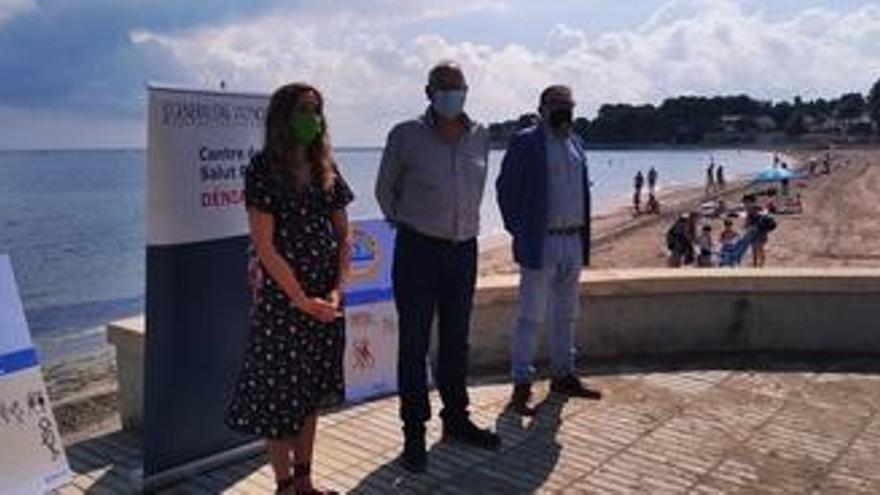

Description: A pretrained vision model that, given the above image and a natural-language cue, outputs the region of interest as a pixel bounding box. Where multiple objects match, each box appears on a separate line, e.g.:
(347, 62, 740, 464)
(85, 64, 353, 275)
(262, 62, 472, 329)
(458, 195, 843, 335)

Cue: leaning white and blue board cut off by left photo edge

(0, 255, 71, 495)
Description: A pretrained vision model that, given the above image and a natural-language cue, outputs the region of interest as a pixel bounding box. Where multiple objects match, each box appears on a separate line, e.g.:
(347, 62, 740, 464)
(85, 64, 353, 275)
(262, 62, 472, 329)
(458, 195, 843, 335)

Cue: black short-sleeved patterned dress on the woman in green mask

(226, 154, 354, 439)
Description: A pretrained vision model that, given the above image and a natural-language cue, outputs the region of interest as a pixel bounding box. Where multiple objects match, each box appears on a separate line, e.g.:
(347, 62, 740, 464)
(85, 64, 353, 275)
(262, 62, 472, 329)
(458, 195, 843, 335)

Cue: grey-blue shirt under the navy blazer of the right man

(544, 128, 587, 229)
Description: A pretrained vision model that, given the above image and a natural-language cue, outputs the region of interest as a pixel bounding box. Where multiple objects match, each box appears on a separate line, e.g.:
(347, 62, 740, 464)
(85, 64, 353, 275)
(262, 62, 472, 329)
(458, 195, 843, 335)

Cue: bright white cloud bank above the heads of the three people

(132, 0, 880, 143)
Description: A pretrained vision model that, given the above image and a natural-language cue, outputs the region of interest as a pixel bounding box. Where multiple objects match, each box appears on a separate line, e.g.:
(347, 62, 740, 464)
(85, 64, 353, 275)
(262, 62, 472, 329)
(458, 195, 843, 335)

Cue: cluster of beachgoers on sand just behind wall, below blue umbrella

(666, 194, 776, 268)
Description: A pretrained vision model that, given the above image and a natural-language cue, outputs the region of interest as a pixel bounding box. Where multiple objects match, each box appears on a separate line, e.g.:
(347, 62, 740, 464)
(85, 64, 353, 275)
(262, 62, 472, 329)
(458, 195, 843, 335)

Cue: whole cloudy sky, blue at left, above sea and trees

(0, 0, 880, 149)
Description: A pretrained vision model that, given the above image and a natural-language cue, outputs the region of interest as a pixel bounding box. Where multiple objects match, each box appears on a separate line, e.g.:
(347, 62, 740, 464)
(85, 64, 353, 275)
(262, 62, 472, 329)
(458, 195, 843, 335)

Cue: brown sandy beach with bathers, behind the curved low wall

(480, 149, 880, 276)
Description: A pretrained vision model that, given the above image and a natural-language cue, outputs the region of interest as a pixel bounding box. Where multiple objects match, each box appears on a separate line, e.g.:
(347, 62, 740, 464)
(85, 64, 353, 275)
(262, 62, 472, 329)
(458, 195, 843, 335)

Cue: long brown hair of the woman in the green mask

(263, 83, 336, 190)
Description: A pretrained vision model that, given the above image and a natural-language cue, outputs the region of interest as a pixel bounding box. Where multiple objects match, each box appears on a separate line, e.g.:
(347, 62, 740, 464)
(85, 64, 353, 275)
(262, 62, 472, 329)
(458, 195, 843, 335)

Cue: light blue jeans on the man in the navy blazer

(510, 235, 583, 384)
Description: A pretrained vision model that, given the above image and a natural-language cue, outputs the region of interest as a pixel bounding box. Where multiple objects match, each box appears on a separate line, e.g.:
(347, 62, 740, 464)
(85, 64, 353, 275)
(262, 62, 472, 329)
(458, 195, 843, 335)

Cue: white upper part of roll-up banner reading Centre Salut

(147, 87, 268, 246)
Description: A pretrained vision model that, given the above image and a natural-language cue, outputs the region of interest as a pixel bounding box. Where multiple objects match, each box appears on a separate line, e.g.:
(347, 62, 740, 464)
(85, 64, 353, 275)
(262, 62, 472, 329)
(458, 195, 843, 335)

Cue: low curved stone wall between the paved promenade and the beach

(108, 268, 880, 429)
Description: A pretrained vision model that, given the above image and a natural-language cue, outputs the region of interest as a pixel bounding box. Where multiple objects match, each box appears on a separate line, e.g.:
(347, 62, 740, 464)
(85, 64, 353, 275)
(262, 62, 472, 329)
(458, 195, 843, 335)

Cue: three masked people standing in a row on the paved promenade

(226, 62, 601, 494)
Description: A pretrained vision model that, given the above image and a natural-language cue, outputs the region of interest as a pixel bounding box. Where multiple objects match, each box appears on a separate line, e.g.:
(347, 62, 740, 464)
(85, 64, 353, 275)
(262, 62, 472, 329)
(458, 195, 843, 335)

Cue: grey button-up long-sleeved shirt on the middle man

(376, 111, 489, 241)
